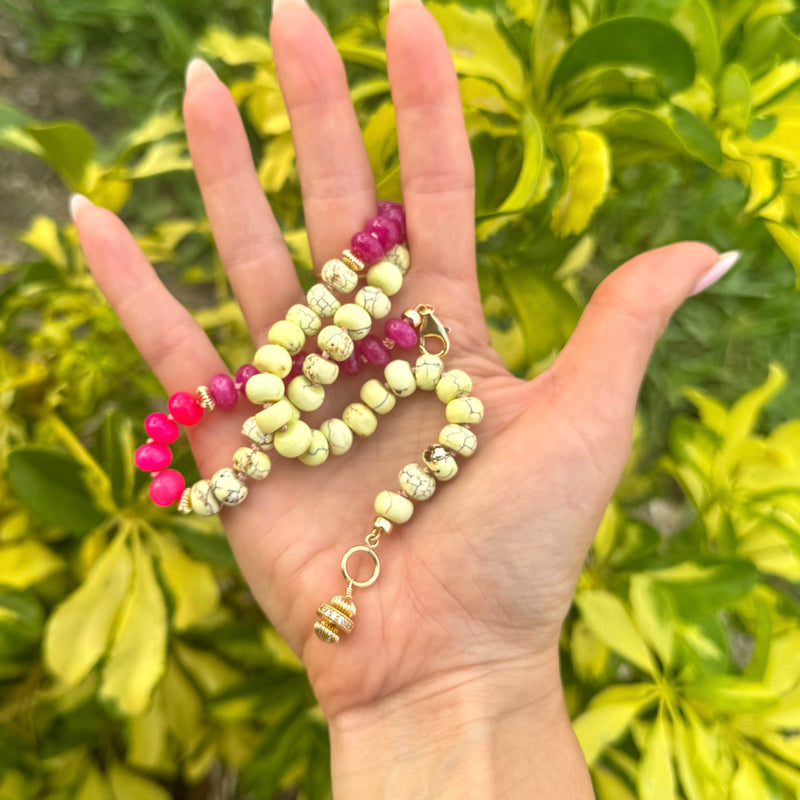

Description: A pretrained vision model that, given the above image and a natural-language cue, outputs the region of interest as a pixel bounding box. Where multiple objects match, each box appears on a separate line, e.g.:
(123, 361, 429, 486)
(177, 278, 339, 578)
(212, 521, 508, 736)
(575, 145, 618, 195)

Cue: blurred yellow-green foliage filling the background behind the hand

(0, 0, 800, 800)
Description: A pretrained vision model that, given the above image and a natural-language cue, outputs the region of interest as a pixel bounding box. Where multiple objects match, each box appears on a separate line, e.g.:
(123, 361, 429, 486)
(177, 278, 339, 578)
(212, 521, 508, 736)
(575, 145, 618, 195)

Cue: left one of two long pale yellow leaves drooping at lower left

(44, 533, 133, 686)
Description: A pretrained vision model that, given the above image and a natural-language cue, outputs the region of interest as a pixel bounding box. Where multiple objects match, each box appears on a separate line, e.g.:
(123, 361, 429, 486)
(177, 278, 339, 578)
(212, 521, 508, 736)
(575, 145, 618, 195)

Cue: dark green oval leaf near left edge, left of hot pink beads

(8, 446, 105, 533)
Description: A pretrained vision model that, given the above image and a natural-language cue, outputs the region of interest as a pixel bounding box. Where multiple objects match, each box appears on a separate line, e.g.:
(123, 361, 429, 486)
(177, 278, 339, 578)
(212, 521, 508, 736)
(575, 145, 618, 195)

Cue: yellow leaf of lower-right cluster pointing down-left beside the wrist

(573, 683, 658, 767)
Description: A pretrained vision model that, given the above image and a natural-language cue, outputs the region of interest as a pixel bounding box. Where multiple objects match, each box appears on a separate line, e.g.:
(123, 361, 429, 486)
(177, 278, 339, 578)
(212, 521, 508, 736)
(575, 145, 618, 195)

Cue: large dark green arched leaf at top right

(549, 17, 695, 95)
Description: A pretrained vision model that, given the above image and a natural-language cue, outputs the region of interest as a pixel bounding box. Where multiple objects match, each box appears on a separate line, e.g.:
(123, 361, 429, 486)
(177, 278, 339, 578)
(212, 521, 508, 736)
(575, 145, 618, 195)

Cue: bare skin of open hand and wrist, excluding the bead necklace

(76, 2, 717, 800)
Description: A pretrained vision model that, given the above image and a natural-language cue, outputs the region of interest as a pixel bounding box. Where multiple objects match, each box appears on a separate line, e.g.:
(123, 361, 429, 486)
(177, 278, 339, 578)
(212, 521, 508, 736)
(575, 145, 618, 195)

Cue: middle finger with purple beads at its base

(270, 0, 377, 267)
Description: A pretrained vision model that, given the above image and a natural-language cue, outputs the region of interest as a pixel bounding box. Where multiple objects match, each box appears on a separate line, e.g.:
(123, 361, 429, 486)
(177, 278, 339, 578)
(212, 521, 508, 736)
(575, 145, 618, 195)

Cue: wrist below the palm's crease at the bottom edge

(329, 652, 594, 800)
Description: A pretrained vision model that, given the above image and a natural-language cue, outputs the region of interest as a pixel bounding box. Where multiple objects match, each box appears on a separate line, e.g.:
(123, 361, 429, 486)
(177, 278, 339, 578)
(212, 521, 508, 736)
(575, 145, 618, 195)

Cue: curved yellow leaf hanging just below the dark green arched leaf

(550, 129, 611, 236)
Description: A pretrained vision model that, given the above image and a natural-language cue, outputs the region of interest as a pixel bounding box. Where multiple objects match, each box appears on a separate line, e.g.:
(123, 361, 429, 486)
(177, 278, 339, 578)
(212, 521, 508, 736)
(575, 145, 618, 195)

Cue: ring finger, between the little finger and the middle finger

(183, 59, 299, 343)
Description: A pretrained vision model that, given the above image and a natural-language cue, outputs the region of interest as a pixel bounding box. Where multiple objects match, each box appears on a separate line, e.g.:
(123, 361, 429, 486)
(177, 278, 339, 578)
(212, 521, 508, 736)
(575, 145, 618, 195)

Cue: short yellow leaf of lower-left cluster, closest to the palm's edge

(153, 536, 219, 631)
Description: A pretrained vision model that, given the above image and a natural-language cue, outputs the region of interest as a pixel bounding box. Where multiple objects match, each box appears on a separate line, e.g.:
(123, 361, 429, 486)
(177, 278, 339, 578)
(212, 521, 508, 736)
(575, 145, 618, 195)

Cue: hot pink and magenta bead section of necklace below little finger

(134, 364, 258, 506)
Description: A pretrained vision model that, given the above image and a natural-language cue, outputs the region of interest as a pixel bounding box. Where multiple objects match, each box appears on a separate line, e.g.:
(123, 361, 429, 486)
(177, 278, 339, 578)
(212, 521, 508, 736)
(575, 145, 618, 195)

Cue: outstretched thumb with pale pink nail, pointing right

(551, 242, 740, 450)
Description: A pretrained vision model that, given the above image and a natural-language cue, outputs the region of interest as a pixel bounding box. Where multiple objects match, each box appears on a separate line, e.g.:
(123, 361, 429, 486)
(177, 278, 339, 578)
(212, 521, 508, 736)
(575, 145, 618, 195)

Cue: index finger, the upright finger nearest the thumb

(386, 0, 488, 342)
